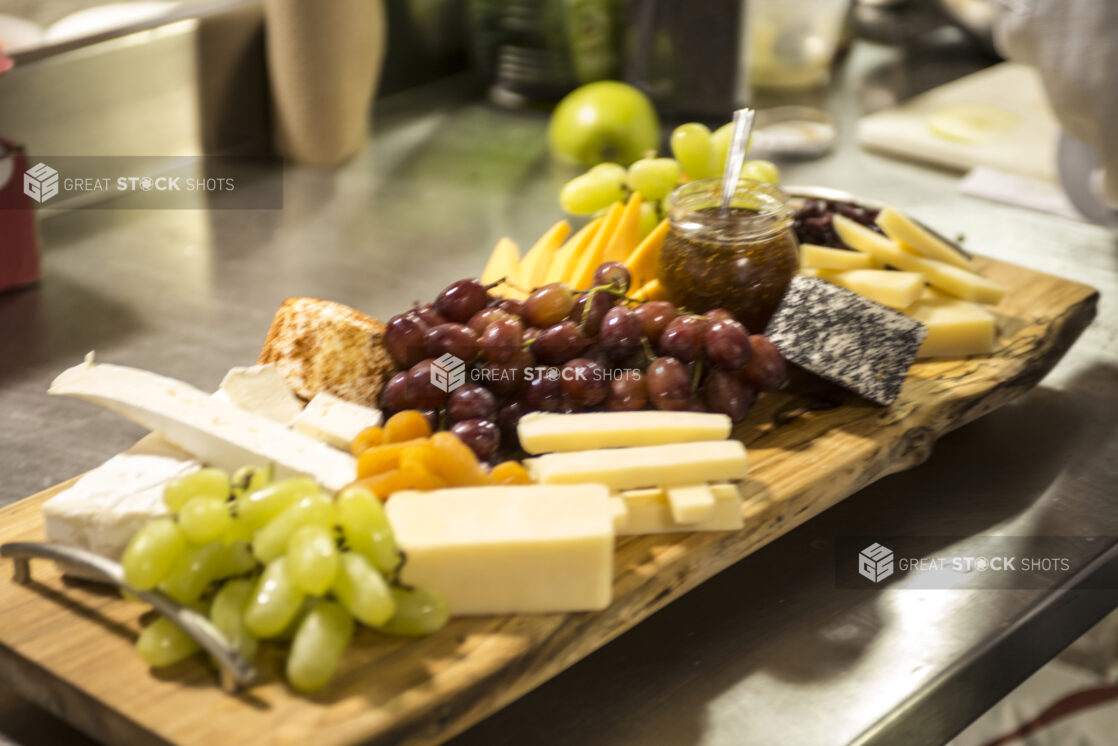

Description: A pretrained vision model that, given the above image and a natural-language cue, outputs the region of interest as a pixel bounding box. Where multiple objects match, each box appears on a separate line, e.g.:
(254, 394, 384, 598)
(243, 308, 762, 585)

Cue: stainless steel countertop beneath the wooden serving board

(0, 36, 1118, 746)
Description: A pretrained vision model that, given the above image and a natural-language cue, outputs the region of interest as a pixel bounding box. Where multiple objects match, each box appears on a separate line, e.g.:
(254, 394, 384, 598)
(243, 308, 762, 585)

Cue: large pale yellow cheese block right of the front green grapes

(386, 484, 614, 615)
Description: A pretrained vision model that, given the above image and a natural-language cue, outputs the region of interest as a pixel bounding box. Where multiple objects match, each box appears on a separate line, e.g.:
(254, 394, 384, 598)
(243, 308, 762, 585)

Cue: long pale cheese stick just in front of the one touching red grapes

(524, 441, 748, 491)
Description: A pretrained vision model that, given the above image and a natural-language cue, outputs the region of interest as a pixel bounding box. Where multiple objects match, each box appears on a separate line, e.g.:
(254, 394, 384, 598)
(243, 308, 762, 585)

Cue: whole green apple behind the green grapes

(548, 81, 660, 166)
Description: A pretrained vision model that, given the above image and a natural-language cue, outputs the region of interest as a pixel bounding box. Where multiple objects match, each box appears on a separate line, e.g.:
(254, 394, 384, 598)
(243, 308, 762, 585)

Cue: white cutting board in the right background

(858, 63, 1060, 182)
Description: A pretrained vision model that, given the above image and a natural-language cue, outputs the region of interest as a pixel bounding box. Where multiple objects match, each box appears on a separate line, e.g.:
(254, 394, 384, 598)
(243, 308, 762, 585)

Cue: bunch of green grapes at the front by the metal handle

(121, 469, 447, 692)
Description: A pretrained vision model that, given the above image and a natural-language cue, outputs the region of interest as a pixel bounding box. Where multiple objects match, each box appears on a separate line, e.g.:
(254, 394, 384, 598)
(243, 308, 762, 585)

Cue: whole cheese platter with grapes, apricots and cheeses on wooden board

(0, 147, 1097, 744)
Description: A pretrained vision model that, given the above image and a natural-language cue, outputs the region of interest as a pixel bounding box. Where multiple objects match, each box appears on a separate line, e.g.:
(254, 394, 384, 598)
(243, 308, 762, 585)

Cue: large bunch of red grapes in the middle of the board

(381, 262, 787, 460)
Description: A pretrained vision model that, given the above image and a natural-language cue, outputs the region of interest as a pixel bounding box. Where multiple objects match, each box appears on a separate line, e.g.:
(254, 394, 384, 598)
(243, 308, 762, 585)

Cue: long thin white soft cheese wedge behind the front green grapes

(48, 356, 357, 491)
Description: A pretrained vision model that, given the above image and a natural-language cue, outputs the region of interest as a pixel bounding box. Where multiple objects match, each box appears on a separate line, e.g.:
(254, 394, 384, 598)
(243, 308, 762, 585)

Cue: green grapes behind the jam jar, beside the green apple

(559, 122, 780, 224)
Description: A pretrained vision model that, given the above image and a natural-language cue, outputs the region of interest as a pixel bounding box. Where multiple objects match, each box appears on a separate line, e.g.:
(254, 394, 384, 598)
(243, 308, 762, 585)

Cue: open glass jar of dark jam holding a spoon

(660, 178, 799, 333)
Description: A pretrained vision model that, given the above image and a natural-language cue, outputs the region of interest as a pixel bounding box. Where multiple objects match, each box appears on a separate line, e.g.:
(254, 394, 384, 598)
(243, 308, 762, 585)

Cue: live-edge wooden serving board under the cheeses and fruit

(0, 257, 1098, 746)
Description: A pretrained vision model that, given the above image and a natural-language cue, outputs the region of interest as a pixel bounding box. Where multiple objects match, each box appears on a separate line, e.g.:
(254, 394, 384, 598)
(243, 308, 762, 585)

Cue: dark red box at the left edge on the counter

(0, 139, 39, 292)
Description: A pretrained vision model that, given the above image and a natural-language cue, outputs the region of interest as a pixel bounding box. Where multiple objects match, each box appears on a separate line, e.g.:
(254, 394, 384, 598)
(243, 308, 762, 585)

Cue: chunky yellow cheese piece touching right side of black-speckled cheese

(906, 290, 997, 358)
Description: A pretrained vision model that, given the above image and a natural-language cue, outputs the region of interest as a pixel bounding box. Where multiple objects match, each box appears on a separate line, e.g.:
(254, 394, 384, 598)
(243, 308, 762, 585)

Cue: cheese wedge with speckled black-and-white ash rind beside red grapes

(765, 276, 928, 406)
